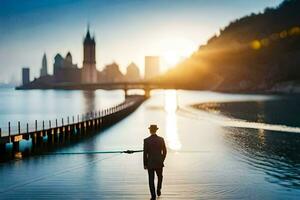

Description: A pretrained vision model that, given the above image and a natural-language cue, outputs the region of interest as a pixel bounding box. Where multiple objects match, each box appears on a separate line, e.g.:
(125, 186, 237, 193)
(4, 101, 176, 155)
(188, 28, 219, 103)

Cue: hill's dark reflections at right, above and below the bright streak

(191, 97, 300, 189)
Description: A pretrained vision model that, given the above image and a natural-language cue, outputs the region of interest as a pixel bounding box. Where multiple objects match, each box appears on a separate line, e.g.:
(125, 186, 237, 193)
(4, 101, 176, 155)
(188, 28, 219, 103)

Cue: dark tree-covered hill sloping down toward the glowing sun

(158, 0, 300, 92)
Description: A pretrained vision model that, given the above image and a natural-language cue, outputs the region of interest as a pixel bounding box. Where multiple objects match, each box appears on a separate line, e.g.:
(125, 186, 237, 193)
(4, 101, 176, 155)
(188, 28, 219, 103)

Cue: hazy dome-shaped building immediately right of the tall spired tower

(100, 62, 124, 83)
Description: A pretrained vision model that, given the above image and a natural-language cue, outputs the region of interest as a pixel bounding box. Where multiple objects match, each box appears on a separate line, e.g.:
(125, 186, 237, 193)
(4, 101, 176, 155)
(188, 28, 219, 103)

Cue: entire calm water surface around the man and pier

(0, 90, 300, 199)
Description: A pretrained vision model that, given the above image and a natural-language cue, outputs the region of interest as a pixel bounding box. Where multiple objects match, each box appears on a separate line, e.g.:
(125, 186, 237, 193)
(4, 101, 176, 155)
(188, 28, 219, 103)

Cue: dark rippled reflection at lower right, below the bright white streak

(225, 128, 300, 189)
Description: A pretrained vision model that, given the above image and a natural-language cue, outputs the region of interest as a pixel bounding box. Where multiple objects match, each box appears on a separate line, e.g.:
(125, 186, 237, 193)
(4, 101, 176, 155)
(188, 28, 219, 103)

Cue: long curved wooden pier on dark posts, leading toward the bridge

(0, 95, 147, 159)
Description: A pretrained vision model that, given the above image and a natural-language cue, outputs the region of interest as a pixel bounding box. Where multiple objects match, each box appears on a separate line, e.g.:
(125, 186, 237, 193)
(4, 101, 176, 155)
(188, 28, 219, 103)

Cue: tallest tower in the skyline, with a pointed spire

(82, 27, 97, 83)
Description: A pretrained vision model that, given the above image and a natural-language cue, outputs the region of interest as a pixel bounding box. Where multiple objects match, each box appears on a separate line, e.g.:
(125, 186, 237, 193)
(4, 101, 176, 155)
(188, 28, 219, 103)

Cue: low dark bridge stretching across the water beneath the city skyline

(16, 81, 177, 98)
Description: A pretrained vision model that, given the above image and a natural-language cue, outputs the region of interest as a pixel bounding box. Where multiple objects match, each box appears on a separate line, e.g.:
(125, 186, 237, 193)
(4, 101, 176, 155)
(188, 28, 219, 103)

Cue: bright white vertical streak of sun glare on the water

(164, 90, 182, 151)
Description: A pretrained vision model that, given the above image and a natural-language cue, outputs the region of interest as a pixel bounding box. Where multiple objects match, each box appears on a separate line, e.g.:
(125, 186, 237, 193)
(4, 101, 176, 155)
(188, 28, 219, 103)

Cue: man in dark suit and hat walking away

(144, 124, 167, 199)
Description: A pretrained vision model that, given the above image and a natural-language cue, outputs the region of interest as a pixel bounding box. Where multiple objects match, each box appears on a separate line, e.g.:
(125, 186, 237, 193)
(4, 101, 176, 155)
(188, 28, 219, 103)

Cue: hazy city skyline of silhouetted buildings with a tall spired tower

(18, 27, 143, 89)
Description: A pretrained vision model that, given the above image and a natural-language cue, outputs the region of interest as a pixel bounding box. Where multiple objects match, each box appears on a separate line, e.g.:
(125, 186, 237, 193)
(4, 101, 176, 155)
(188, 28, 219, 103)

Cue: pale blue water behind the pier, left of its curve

(0, 89, 124, 134)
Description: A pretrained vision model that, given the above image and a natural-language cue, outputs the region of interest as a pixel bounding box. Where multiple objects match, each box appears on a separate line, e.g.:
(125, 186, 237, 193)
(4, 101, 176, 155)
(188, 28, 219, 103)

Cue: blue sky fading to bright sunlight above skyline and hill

(0, 0, 282, 82)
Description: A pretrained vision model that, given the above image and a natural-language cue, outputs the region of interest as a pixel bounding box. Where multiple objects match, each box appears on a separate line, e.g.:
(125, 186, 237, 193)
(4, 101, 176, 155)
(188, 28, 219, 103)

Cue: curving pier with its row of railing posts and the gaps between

(0, 95, 145, 153)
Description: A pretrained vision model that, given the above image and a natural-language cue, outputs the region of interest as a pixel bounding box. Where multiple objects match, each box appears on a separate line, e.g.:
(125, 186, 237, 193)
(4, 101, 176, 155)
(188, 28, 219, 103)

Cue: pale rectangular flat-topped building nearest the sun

(145, 56, 160, 80)
